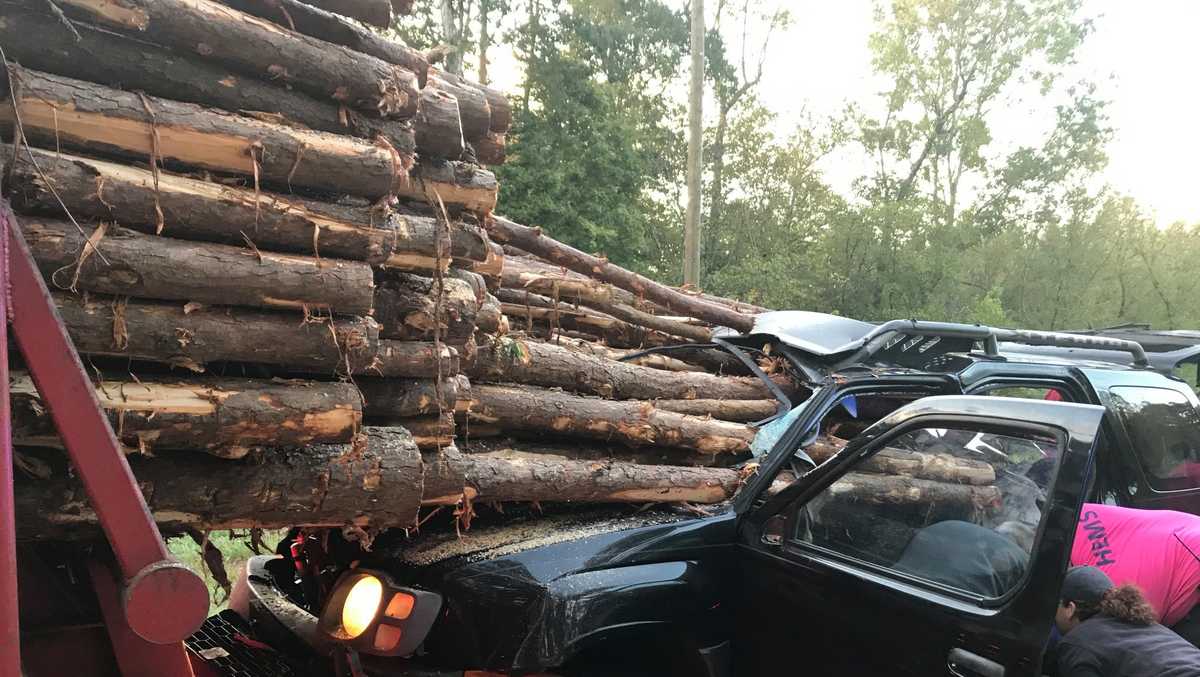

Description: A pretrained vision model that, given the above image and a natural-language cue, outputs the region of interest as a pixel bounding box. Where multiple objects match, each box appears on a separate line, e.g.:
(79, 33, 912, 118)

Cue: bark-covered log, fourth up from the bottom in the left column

(19, 217, 374, 314)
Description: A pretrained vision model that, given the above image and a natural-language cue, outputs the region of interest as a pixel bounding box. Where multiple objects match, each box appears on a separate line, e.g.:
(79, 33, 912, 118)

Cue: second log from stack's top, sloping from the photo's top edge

(221, 0, 430, 81)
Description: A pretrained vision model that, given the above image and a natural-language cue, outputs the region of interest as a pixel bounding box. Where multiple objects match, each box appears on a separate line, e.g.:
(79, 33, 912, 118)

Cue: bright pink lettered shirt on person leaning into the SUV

(1070, 503, 1200, 625)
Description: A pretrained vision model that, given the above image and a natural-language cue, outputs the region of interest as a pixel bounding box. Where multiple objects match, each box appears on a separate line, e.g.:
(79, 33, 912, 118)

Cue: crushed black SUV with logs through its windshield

(235, 312, 1200, 677)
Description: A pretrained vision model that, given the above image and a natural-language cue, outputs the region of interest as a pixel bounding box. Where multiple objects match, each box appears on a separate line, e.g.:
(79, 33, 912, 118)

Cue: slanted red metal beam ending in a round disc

(0, 200, 209, 657)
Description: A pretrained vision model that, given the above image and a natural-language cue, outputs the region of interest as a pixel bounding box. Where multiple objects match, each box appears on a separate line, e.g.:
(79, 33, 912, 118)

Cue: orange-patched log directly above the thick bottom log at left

(8, 372, 362, 459)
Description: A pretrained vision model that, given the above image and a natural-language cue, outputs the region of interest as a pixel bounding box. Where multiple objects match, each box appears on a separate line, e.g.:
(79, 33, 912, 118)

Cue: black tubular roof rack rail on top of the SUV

(844, 319, 1150, 367)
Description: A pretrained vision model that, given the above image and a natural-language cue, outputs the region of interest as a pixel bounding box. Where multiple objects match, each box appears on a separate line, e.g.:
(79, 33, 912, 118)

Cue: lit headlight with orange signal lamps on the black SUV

(318, 569, 442, 655)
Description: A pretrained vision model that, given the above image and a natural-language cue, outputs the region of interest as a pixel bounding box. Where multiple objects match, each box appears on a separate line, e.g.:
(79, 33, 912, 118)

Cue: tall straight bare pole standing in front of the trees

(683, 0, 704, 288)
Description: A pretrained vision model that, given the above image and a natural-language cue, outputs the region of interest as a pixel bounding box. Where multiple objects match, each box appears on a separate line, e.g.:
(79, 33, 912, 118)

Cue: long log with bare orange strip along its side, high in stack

(0, 66, 407, 199)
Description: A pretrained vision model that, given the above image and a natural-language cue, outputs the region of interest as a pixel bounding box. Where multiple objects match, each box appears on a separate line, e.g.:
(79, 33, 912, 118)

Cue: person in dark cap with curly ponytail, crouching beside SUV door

(1055, 567, 1200, 677)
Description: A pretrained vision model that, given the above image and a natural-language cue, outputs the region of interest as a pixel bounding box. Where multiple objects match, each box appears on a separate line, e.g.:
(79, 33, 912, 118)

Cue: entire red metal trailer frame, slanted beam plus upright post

(0, 199, 209, 677)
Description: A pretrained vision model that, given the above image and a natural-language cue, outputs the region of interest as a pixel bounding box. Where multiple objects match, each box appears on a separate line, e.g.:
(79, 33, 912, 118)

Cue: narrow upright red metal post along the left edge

(0, 187, 20, 677)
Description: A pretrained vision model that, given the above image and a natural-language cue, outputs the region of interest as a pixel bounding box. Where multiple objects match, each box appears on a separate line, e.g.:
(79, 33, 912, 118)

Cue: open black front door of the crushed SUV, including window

(732, 396, 1104, 677)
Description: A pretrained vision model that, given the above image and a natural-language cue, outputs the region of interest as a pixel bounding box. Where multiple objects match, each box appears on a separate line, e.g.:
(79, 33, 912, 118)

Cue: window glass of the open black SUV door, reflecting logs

(794, 427, 1058, 598)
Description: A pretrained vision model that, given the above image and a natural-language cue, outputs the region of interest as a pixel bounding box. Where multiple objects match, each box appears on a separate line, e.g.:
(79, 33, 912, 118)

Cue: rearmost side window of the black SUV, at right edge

(1109, 387, 1200, 491)
